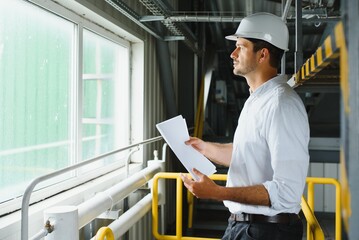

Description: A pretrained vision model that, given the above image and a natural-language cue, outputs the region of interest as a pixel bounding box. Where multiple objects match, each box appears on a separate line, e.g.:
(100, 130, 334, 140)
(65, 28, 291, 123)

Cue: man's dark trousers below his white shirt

(222, 218, 303, 240)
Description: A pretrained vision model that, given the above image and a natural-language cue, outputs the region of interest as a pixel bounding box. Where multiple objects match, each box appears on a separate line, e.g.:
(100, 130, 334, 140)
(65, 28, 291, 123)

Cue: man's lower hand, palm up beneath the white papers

(181, 168, 222, 200)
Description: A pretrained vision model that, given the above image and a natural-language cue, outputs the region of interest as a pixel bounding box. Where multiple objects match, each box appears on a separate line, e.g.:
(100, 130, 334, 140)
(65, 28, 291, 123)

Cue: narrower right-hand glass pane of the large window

(83, 30, 129, 163)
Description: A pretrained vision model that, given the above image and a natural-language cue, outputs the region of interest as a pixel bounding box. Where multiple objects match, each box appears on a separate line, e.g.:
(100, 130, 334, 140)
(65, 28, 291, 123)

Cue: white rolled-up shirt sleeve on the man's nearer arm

(263, 99, 309, 210)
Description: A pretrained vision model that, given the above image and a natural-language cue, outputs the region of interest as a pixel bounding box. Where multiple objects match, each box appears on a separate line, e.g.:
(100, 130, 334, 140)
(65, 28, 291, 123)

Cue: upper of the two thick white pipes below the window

(78, 164, 161, 228)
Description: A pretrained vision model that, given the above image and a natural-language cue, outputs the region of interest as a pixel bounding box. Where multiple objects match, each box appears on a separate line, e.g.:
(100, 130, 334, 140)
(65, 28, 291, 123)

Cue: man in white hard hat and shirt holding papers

(182, 13, 309, 240)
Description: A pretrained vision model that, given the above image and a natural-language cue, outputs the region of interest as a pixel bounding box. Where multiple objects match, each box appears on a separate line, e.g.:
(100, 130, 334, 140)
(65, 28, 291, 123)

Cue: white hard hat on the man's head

(226, 13, 289, 51)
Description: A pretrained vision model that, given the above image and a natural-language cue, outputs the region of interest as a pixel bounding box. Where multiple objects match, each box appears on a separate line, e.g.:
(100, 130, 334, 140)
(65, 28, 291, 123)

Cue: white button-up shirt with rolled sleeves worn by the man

(224, 76, 310, 216)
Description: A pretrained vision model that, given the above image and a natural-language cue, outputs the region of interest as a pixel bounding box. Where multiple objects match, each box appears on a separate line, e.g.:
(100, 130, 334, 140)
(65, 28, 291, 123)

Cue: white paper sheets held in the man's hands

(156, 115, 216, 180)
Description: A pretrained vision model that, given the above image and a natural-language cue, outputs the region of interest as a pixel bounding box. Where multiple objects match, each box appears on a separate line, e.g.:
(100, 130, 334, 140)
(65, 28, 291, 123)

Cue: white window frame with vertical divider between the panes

(0, 0, 143, 215)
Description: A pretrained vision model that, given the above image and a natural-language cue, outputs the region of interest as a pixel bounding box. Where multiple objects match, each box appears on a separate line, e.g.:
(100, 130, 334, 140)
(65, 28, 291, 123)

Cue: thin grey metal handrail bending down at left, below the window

(21, 136, 162, 240)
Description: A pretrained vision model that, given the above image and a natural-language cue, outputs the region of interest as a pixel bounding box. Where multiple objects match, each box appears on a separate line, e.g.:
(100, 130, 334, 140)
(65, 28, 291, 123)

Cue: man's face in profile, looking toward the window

(231, 38, 258, 77)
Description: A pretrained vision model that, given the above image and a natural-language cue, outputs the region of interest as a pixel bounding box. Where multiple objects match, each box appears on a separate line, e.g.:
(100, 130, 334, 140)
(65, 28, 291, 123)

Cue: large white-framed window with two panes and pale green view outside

(0, 0, 134, 206)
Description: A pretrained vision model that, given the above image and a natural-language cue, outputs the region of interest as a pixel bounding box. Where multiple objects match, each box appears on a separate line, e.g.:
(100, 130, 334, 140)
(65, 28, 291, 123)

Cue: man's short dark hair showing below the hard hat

(246, 38, 284, 68)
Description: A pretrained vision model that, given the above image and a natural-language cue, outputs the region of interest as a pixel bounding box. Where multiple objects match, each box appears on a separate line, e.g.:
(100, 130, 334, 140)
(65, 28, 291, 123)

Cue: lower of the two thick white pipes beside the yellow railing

(92, 193, 152, 240)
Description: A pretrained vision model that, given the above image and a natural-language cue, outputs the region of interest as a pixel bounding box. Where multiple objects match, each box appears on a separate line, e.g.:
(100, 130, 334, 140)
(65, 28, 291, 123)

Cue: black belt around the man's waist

(229, 213, 299, 224)
